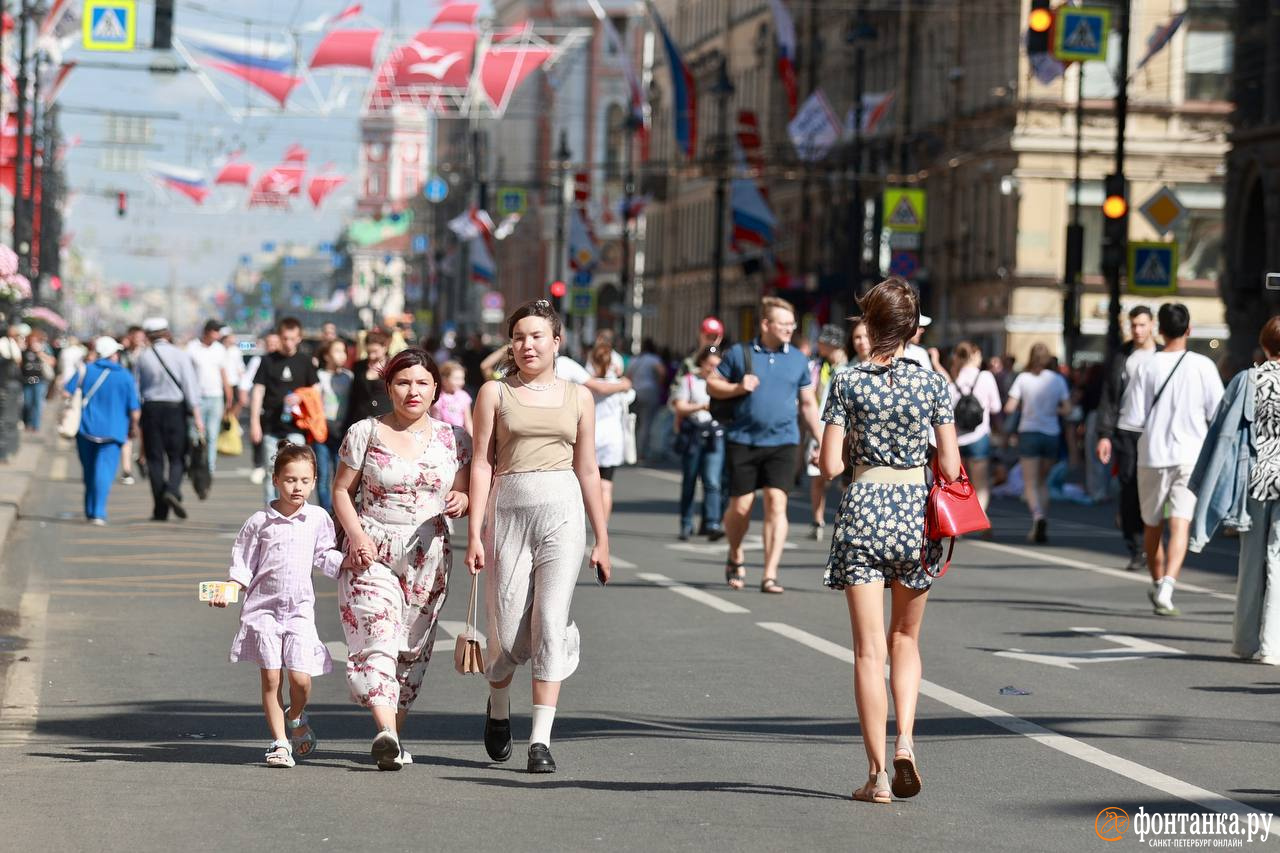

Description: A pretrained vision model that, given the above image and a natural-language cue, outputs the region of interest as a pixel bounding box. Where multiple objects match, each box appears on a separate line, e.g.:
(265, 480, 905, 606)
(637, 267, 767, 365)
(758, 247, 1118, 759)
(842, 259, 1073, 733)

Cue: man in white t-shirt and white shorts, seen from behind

(1119, 302, 1222, 616)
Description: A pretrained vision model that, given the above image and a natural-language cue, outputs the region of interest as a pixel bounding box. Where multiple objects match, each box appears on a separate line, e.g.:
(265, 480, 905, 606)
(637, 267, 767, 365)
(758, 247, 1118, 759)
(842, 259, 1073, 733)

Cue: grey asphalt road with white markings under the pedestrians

(0, 438, 1280, 852)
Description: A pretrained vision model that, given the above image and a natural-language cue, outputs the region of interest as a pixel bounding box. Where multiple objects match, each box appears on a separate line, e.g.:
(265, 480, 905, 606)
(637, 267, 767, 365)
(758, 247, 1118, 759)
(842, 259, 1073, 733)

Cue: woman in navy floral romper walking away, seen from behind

(819, 278, 960, 803)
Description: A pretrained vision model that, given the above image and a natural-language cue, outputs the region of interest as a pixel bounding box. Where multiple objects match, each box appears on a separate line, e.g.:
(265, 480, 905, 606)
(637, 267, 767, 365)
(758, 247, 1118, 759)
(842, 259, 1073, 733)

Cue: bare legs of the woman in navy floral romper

(845, 584, 929, 775)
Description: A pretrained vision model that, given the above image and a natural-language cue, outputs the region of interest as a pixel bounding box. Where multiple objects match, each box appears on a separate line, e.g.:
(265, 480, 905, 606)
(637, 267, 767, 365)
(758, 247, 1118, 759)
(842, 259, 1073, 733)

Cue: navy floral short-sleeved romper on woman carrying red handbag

(822, 359, 955, 589)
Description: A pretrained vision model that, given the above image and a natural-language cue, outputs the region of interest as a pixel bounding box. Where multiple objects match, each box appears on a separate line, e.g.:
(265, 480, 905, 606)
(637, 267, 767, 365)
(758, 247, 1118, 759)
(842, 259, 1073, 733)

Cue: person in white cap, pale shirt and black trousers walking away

(134, 316, 205, 521)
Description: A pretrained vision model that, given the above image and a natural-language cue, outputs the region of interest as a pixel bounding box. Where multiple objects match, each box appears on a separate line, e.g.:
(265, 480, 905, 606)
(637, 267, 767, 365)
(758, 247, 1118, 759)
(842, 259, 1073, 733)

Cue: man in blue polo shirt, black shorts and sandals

(707, 297, 822, 593)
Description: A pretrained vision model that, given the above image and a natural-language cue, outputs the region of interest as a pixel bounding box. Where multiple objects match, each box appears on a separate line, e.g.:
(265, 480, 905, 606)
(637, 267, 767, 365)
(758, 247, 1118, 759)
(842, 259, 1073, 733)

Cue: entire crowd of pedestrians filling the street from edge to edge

(0, 278, 1280, 803)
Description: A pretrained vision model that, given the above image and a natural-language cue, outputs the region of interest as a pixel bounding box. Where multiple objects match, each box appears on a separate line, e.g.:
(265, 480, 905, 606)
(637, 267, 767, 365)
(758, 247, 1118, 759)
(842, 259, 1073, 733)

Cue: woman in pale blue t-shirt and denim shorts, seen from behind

(1005, 342, 1071, 544)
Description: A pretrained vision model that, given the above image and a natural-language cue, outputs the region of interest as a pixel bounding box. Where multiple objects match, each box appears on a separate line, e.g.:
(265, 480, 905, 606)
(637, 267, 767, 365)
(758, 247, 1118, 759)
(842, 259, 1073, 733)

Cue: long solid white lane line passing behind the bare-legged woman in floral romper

(756, 622, 1260, 815)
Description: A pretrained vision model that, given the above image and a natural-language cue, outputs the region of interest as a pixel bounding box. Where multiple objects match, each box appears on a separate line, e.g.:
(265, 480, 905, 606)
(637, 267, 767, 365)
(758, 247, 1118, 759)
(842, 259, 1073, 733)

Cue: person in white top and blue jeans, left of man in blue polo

(671, 346, 724, 542)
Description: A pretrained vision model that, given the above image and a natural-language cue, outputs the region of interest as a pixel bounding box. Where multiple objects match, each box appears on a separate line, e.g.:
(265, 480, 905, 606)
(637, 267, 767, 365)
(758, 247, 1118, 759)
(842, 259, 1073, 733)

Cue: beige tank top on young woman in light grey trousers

(494, 380, 579, 475)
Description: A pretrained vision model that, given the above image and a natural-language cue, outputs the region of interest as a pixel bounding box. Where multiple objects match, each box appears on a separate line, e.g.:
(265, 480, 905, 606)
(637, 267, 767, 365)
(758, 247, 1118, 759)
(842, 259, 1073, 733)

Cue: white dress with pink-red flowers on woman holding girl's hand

(338, 418, 471, 708)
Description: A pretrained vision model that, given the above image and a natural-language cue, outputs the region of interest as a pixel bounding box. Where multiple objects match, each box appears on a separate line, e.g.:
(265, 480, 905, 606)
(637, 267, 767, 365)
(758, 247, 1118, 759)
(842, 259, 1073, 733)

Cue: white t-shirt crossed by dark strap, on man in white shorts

(1120, 352, 1222, 467)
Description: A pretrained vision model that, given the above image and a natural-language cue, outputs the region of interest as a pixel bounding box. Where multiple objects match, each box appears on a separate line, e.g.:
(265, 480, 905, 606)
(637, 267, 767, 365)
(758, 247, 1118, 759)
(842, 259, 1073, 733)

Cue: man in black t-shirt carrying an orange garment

(248, 316, 320, 501)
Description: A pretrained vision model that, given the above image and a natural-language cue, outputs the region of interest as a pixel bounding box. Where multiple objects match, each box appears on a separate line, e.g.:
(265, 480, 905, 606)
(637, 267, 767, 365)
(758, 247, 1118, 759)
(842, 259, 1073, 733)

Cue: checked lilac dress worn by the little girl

(230, 503, 342, 675)
